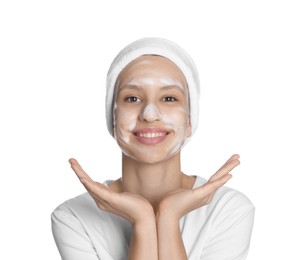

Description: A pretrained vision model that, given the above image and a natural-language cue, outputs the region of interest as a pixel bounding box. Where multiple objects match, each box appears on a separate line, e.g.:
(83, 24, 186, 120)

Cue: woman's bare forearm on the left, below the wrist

(128, 217, 158, 260)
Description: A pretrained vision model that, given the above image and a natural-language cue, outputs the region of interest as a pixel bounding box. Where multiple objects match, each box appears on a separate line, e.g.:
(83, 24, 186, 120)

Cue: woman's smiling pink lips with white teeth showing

(133, 128, 170, 144)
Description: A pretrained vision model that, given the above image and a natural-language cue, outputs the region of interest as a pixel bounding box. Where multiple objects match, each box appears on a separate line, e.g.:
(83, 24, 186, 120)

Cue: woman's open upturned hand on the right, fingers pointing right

(157, 154, 240, 221)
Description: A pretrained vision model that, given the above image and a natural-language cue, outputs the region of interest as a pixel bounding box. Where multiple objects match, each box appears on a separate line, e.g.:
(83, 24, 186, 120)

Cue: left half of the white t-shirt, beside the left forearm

(51, 192, 129, 259)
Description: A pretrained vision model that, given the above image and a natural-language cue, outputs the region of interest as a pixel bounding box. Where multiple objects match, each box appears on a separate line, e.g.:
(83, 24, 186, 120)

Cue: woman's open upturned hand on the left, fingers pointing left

(69, 158, 155, 224)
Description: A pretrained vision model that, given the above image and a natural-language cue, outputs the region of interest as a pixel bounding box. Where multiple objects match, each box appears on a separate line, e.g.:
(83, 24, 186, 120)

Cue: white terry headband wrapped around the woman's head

(106, 38, 200, 138)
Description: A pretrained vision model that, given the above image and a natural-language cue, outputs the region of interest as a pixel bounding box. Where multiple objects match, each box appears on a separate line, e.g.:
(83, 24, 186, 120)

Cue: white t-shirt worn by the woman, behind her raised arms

(51, 176, 254, 260)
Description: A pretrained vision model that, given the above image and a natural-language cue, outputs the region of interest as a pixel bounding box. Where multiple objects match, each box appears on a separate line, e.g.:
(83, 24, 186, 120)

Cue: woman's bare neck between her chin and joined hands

(121, 153, 186, 207)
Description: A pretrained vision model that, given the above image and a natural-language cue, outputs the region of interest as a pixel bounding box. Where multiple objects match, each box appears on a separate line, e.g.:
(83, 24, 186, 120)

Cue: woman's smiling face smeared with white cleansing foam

(113, 56, 191, 163)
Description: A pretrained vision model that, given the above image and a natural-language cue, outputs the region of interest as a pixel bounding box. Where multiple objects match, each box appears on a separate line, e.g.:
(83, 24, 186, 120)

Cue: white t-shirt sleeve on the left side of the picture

(51, 205, 100, 260)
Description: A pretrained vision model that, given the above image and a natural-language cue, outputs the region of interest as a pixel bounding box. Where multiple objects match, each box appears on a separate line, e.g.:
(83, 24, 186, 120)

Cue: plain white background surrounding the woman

(0, 0, 305, 260)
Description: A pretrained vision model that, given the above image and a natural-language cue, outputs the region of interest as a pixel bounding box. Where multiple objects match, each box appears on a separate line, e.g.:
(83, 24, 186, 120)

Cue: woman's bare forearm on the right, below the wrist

(157, 215, 187, 260)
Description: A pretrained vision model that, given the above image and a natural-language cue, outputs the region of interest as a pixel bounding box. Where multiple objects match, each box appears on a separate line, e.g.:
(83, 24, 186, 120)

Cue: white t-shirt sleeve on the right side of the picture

(200, 193, 255, 260)
